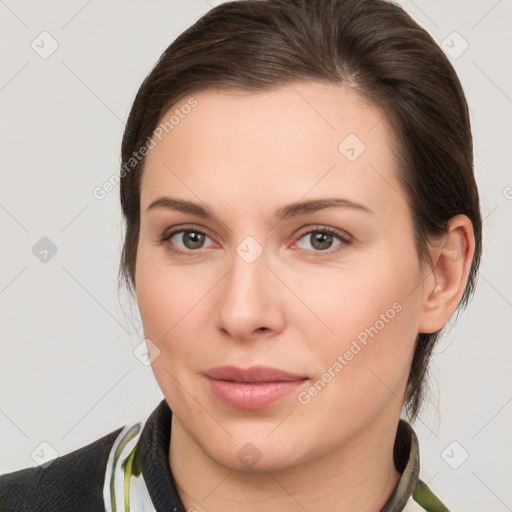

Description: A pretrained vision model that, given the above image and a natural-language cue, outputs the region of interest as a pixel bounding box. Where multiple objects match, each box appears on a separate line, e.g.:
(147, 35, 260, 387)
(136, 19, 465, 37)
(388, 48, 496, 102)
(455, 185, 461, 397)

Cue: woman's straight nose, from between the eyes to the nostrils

(217, 242, 286, 341)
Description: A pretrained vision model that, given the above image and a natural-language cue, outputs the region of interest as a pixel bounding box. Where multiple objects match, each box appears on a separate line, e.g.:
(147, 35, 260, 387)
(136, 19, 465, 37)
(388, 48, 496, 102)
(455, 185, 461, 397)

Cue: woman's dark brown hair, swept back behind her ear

(120, 0, 482, 419)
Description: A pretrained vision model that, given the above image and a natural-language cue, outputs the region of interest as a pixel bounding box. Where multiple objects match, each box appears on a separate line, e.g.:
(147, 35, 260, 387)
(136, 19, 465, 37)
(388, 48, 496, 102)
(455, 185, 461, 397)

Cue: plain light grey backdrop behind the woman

(0, 0, 512, 512)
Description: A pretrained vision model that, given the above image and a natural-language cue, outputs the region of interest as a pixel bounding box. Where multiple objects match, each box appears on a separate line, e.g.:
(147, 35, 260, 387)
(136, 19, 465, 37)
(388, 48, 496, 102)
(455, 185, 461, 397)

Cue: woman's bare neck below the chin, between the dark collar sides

(169, 416, 400, 512)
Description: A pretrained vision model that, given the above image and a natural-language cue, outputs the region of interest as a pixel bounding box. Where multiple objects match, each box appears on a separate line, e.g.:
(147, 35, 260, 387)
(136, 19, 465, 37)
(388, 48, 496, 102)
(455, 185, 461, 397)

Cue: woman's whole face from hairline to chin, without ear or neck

(136, 82, 425, 470)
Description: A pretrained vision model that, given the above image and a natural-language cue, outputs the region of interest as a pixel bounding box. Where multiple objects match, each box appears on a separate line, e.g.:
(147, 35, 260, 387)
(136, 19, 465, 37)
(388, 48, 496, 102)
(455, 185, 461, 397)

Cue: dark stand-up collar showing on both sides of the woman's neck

(136, 399, 420, 512)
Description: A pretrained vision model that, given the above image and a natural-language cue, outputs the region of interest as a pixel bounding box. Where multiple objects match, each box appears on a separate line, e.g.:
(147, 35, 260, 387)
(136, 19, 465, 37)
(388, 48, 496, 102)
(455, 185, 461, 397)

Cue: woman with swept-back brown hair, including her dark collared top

(1, 0, 481, 512)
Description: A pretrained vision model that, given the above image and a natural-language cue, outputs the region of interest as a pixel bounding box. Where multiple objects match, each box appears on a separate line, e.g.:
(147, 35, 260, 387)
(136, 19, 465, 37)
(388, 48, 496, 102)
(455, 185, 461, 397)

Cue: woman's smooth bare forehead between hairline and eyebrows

(141, 82, 398, 214)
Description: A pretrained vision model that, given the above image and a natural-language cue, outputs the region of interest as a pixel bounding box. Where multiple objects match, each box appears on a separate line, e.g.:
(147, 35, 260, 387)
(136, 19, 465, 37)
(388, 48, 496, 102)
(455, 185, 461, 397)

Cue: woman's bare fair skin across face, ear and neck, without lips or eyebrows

(135, 82, 474, 512)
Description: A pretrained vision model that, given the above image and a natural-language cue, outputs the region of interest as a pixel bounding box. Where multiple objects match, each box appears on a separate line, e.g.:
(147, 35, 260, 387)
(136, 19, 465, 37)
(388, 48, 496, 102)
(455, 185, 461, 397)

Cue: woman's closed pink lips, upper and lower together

(205, 366, 308, 410)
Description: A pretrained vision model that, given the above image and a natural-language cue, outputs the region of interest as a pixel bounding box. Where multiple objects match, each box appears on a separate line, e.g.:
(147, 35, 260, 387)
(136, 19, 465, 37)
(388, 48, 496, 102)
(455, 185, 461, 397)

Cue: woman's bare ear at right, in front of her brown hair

(418, 215, 475, 333)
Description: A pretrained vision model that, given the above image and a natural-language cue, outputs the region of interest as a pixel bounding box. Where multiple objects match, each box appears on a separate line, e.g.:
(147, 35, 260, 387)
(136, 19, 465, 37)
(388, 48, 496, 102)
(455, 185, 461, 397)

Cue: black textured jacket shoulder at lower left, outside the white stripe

(0, 427, 123, 512)
